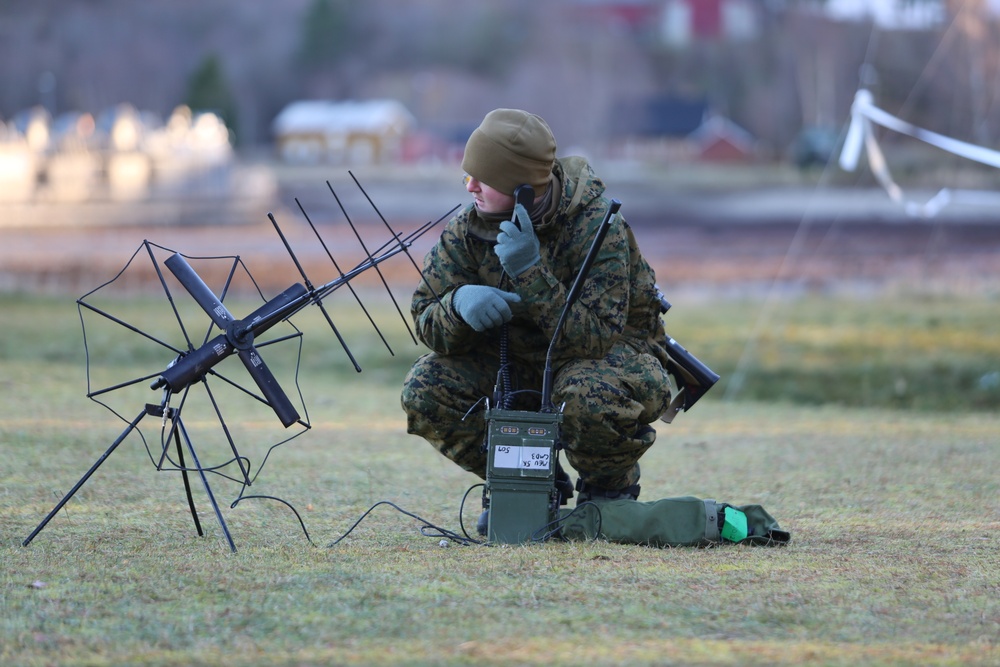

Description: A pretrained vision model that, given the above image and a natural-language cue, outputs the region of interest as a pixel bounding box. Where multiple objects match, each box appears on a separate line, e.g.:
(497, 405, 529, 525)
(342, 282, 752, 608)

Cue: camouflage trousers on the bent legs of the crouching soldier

(401, 342, 670, 490)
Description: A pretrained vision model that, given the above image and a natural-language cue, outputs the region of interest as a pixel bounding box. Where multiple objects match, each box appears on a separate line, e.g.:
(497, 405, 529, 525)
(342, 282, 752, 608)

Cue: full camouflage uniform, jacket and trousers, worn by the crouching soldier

(402, 157, 670, 490)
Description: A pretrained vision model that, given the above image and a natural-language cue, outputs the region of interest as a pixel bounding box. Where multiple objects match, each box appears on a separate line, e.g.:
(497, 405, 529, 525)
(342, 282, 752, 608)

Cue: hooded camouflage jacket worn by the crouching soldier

(411, 157, 667, 367)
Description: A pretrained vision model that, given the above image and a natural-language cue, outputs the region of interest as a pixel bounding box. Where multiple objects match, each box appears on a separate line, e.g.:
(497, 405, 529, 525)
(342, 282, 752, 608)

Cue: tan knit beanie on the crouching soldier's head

(462, 109, 556, 196)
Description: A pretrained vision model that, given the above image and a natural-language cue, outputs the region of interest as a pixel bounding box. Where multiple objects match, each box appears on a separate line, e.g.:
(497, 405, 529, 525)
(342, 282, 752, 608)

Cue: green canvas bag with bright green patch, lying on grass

(559, 496, 791, 548)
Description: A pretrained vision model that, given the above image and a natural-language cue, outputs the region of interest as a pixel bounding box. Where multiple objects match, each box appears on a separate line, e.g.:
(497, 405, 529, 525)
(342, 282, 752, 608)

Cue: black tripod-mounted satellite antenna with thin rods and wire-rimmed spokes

(22, 174, 459, 551)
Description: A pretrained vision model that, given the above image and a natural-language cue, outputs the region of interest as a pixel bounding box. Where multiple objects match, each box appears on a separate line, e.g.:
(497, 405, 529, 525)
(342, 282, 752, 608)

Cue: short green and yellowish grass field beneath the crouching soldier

(0, 296, 1000, 665)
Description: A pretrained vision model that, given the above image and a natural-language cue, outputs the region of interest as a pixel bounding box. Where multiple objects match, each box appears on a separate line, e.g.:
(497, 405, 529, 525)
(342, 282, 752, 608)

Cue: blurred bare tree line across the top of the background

(0, 0, 1000, 157)
